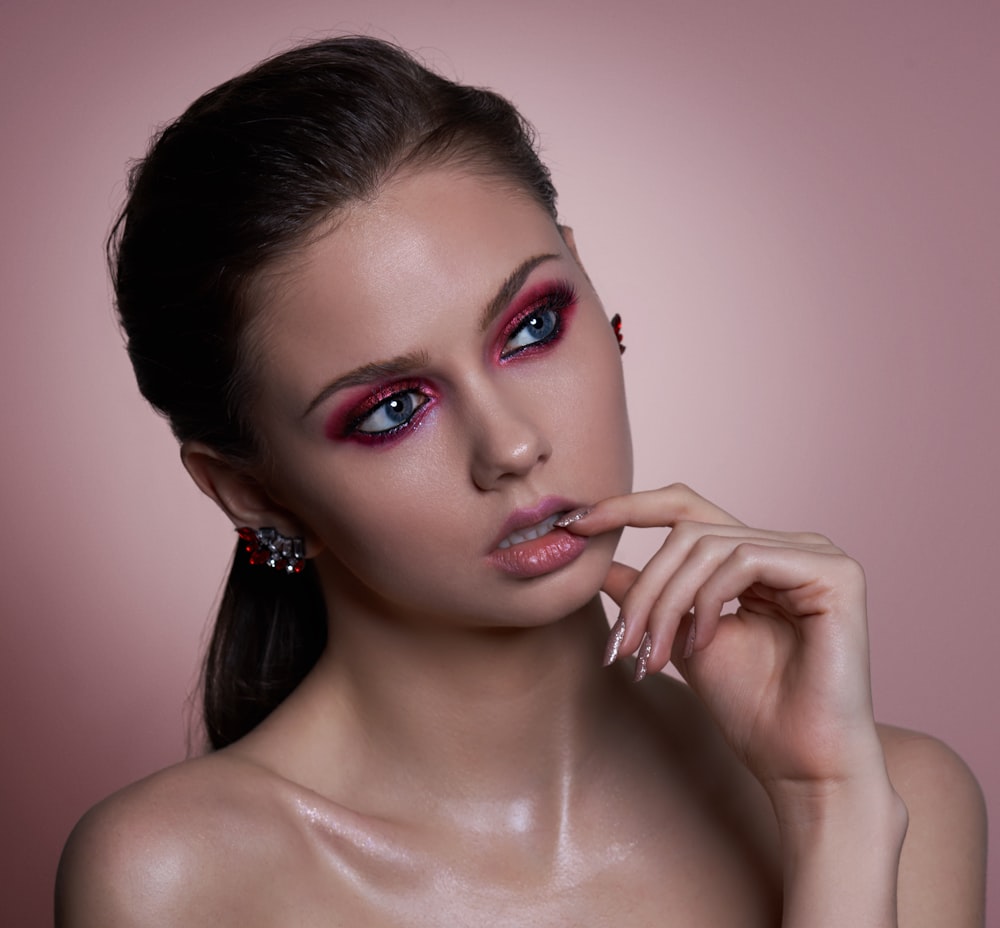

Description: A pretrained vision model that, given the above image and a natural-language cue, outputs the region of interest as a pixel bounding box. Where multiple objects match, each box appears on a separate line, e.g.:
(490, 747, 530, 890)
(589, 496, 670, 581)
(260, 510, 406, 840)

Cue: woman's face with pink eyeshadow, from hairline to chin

(251, 168, 632, 626)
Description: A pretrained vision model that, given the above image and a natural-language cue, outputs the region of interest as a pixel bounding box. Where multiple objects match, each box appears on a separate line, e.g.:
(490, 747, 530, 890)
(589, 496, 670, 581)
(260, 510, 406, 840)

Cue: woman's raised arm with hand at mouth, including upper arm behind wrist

(567, 485, 983, 928)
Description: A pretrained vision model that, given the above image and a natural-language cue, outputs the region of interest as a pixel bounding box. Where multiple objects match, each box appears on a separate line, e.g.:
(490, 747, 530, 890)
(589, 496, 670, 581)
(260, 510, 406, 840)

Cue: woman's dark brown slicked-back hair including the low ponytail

(108, 36, 556, 748)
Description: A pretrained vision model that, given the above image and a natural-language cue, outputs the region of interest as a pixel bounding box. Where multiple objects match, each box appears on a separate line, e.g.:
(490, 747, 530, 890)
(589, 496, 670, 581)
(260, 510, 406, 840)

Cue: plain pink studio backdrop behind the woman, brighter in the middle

(0, 0, 1000, 925)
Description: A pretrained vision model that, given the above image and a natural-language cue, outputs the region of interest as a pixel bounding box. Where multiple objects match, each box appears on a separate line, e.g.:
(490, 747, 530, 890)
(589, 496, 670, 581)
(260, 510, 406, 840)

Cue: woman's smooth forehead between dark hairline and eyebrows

(252, 168, 568, 369)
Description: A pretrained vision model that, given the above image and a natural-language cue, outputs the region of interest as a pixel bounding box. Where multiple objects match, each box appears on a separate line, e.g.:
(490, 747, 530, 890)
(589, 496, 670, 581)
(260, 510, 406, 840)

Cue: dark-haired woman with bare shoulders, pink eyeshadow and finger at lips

(57, 38, 984, 928)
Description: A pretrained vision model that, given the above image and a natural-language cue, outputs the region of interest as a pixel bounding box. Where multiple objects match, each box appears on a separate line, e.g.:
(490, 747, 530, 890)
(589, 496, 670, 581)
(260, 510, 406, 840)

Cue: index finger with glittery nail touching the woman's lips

(556, 483, 743, 535)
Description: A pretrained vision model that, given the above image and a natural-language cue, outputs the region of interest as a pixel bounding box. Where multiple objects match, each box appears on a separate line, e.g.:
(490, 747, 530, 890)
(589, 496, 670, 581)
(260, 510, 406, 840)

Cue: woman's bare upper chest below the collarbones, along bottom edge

(257, 804, 781, 928)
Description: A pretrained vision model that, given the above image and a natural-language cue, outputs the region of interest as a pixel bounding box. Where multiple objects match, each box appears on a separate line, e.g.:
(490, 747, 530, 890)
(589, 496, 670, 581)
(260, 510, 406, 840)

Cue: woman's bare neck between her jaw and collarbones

(292, 598, 626, 815)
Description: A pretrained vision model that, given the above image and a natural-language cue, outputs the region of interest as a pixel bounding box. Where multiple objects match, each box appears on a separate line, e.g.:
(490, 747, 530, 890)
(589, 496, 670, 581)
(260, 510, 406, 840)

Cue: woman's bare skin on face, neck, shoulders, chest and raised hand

(57, 168, 985, 928)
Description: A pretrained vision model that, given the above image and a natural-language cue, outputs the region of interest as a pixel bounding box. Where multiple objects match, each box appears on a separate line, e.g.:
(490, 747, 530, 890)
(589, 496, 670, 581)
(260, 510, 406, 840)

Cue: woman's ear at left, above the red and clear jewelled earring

(181, 441, 316, 556)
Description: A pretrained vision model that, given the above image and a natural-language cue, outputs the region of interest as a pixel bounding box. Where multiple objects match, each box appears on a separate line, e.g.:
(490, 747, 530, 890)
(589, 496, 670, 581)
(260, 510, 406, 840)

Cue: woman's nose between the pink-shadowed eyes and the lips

(470, 386, 552, 490)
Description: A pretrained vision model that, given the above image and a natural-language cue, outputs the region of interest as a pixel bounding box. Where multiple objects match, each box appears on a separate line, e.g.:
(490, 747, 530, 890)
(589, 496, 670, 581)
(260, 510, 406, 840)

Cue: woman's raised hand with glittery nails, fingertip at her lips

(566, 485, 887, 811)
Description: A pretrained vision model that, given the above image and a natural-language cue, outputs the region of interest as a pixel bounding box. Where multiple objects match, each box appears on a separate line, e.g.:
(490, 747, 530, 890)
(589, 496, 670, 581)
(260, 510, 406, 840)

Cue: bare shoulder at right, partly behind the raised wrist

(879, 726, 986, 928)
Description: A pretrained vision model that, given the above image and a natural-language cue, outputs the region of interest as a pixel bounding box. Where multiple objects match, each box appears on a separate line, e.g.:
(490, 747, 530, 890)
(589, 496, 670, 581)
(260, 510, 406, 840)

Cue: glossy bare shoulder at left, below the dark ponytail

(56, 755, 294, 928)
